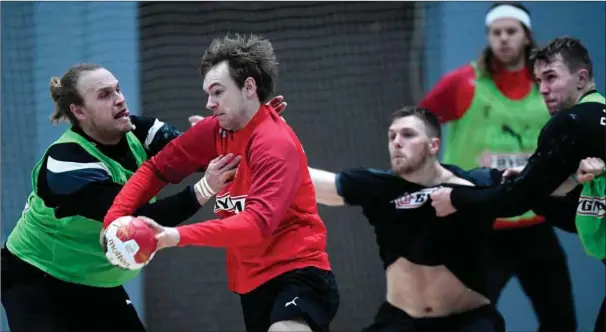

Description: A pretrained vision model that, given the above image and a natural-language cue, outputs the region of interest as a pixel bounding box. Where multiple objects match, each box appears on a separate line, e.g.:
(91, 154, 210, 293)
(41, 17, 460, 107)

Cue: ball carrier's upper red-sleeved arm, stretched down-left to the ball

(103, 117, 219, 229)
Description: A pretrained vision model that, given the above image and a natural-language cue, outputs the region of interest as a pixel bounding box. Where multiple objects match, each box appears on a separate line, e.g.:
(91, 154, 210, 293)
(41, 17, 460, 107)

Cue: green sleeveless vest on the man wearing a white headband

(442, 63, 550, 222)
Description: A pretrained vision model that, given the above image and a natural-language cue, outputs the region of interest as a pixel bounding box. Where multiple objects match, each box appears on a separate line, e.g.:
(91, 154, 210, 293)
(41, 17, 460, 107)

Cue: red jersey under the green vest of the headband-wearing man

(419, 65, 545, 230)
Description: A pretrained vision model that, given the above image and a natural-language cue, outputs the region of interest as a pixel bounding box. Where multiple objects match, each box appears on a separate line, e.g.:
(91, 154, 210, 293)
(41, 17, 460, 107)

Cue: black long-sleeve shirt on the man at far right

(451, 93, 606, 228)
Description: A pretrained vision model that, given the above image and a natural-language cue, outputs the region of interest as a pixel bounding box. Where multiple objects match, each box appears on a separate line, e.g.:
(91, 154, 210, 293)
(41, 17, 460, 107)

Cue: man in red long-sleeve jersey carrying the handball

(104, 35, 339, 332)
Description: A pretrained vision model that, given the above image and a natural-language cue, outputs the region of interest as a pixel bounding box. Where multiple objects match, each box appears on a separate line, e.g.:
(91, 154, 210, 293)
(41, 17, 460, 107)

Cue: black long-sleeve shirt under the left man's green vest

(38, 116, 200, 226)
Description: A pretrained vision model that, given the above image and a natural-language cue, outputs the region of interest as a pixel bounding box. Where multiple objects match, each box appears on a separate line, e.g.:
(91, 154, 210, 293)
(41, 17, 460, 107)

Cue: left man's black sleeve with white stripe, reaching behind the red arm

(45, 144, 200, 226)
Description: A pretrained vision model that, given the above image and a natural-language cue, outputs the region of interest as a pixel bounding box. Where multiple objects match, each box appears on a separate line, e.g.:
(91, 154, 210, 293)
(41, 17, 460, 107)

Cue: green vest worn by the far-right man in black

(575, 92, 606, 259)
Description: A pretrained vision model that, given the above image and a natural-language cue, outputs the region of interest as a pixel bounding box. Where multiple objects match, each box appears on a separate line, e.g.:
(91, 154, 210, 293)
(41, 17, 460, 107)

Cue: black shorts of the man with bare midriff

(362, 302, 505, 332)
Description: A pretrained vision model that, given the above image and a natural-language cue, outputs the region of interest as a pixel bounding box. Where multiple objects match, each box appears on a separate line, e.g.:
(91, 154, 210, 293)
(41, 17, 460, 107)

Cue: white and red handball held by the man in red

(105, 216, 158, 270)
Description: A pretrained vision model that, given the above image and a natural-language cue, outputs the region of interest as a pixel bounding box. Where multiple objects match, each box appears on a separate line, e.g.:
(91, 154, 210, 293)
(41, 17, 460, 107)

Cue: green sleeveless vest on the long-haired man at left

(6, 130, 153, 287)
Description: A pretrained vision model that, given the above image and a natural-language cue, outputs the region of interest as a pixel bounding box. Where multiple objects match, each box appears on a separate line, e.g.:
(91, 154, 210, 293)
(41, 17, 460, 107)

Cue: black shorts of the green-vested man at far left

(1, 248, 145, 332)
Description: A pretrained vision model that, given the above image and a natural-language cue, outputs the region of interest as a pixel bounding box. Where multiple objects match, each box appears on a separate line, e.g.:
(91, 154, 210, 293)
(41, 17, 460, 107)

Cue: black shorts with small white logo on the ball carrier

(240, 267, 339, 332)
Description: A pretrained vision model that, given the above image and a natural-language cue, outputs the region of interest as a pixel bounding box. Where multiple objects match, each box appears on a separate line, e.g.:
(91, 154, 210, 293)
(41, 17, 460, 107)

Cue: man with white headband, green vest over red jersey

(420, 3, 577, 331)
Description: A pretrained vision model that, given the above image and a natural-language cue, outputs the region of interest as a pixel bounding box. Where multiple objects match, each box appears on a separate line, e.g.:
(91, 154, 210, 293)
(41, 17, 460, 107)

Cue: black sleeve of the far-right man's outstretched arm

(451, 107, 585, 217)
